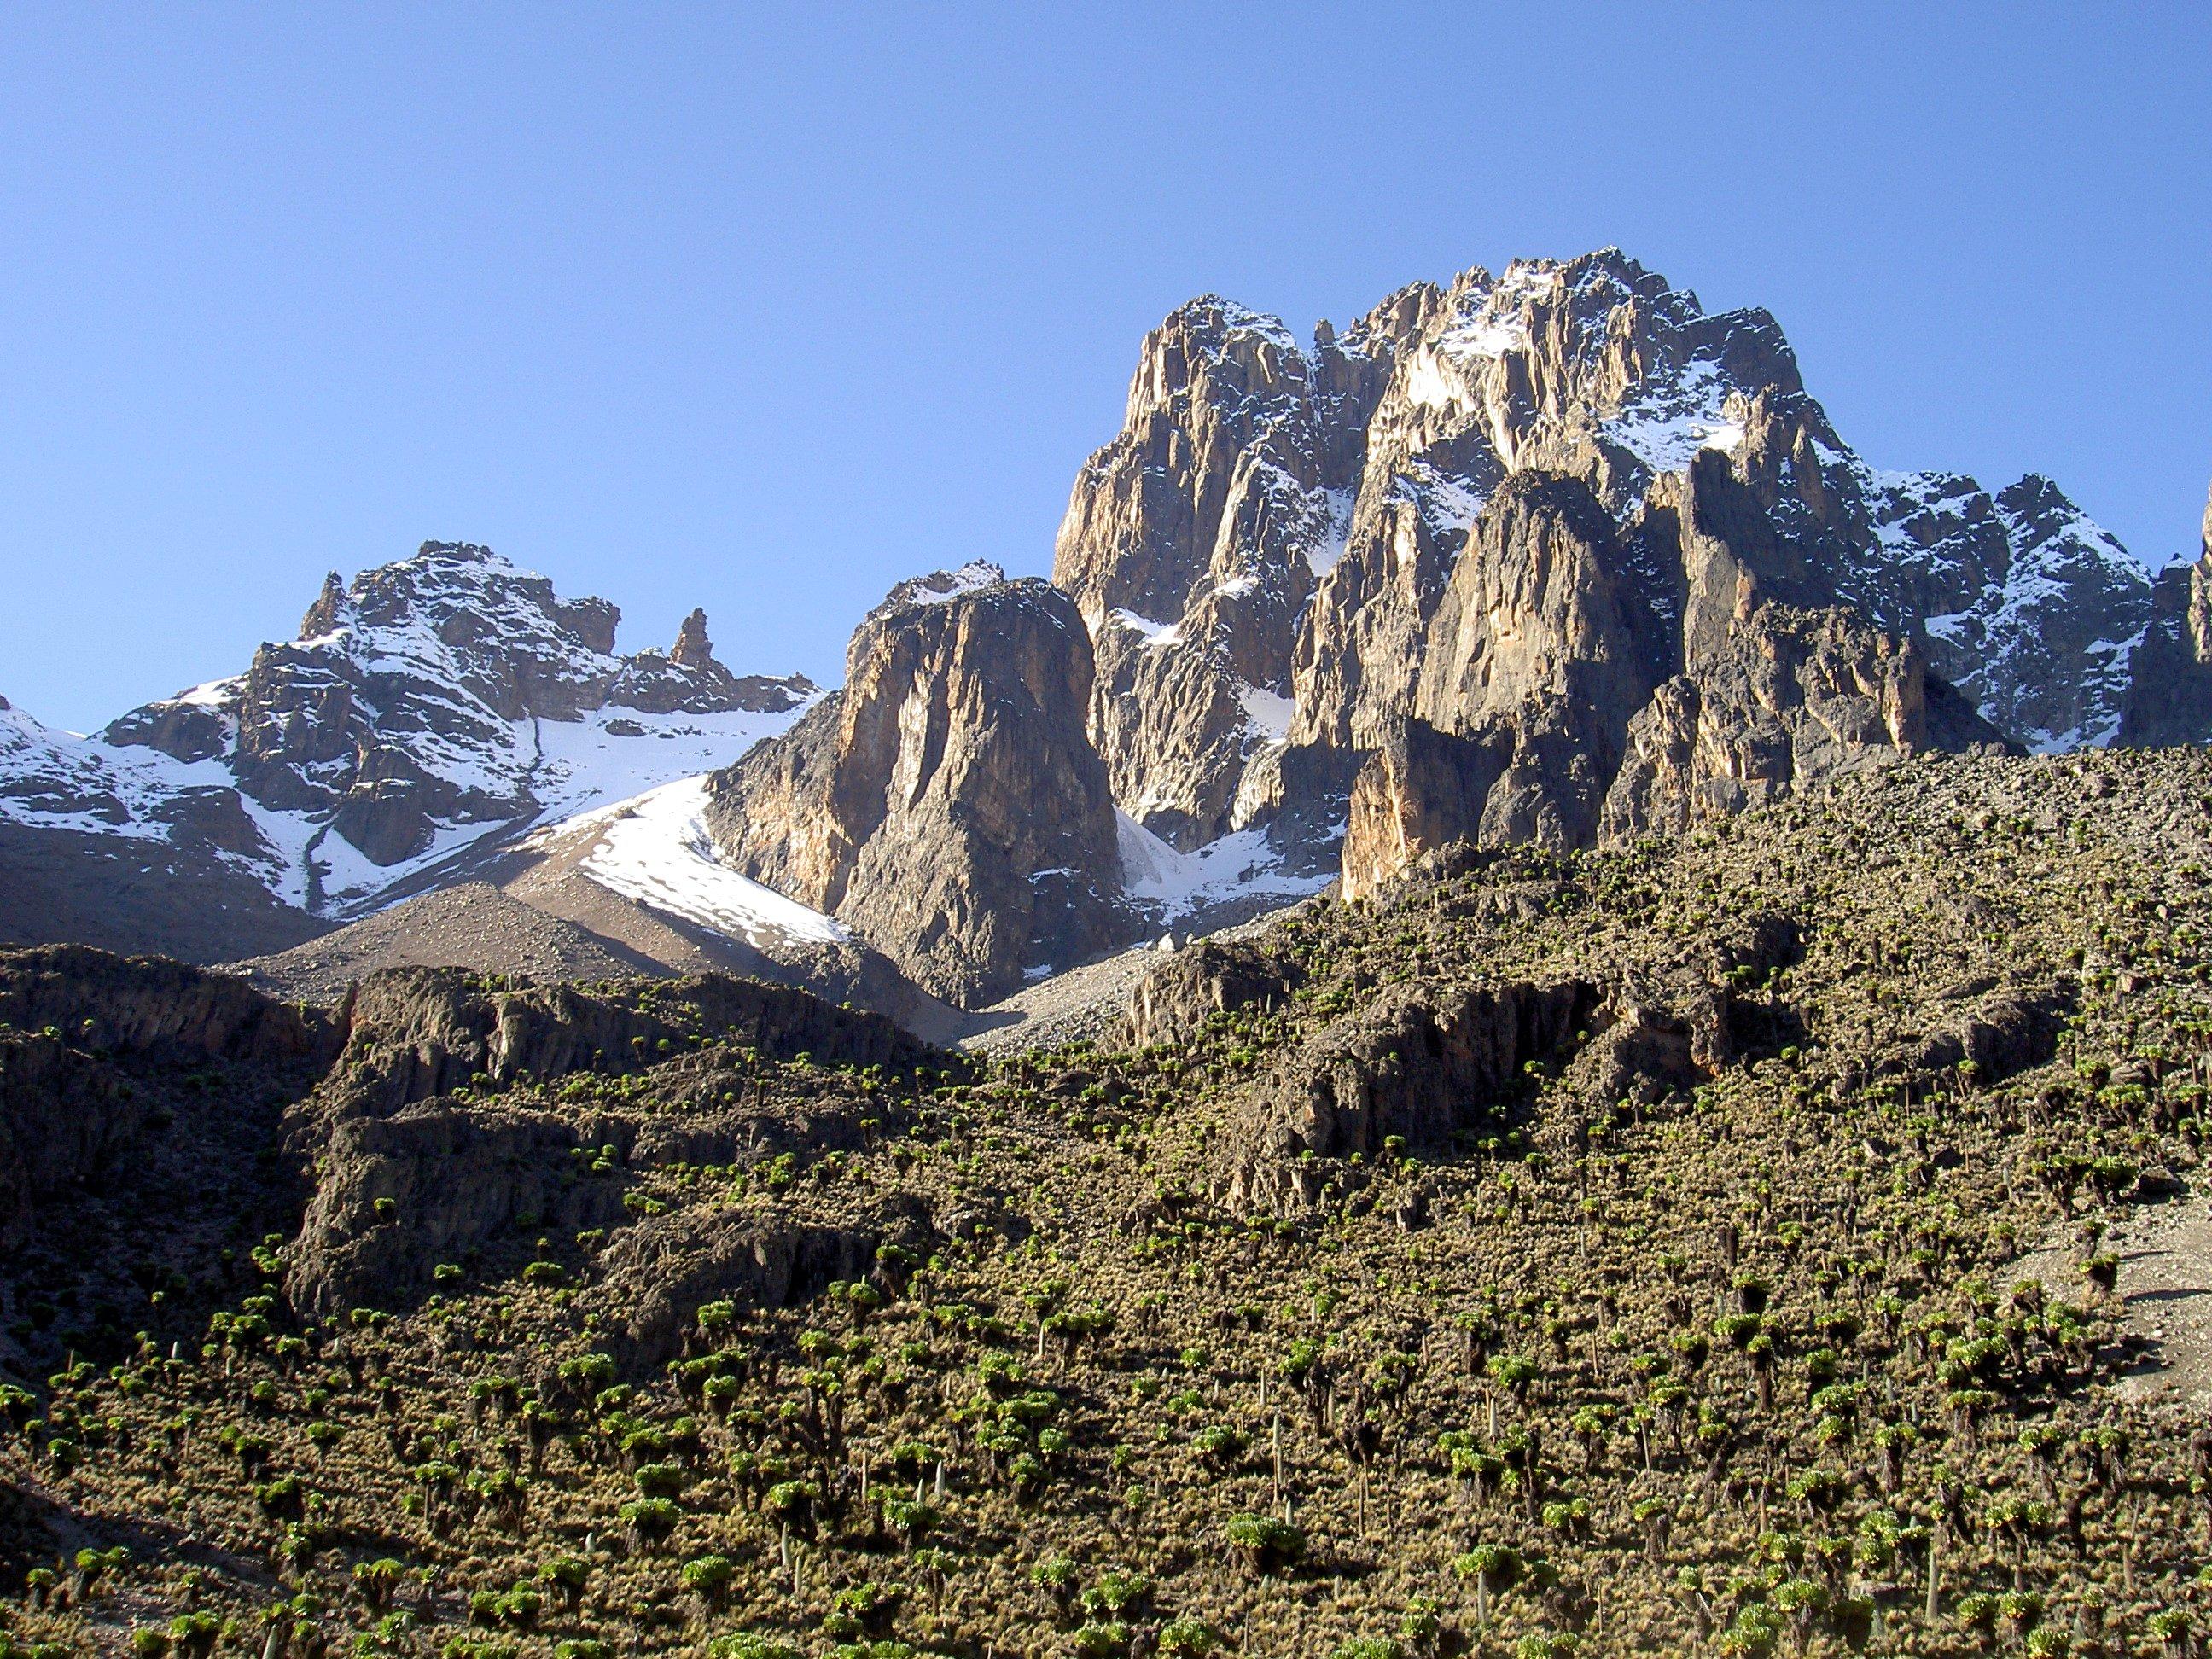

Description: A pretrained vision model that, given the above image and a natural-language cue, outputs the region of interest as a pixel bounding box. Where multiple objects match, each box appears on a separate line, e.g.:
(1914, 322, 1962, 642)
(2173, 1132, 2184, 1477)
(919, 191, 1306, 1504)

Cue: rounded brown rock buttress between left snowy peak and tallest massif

(707, 564, 1120, 1004)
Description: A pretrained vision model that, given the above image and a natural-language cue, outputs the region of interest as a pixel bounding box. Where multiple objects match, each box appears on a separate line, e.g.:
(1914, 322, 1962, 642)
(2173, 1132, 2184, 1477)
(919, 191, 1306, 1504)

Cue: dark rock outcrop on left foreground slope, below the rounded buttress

(288, 969, 931, 1314)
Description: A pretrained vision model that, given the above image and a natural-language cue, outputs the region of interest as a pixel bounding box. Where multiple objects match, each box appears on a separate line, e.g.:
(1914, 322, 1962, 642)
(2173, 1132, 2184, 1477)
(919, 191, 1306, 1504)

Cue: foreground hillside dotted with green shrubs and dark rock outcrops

(0, 748, 2212, 1659)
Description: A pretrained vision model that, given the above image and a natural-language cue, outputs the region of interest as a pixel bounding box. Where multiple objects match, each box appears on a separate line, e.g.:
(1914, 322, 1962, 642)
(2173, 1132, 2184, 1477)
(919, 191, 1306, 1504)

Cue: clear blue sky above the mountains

(0, 0, 2212, 728)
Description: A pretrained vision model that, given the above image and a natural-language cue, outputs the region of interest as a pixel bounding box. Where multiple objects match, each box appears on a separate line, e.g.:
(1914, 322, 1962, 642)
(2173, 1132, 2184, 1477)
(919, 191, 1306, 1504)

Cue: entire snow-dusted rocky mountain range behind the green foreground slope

(0, 250, 2212, 1022)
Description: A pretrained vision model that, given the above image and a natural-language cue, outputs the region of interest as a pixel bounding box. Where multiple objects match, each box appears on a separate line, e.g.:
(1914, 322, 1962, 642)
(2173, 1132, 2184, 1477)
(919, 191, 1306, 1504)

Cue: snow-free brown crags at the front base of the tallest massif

(1342, 447, 2004, 896)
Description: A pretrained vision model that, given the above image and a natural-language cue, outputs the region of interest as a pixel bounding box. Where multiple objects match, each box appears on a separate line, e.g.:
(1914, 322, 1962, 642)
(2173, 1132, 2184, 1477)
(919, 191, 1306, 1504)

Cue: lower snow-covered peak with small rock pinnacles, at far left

(0, 542, 816, 928)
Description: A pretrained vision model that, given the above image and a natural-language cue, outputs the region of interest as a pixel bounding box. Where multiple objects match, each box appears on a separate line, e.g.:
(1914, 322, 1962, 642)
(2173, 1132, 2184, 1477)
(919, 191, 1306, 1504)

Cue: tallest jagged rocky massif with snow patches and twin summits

(1055, 250, 2150, 889)
